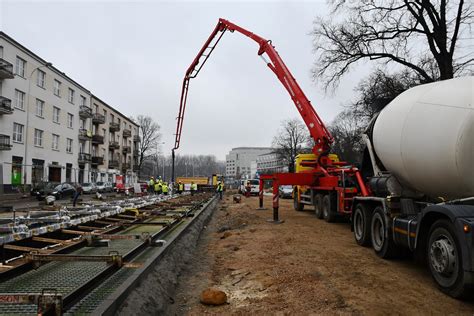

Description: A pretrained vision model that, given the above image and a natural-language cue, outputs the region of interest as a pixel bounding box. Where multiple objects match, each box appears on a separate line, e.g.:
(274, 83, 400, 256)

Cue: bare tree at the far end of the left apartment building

(137, 115, 161, 175)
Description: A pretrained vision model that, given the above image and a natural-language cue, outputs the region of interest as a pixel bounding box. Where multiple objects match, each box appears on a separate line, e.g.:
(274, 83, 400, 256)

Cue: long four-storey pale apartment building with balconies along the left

(0, 32, 139, 191)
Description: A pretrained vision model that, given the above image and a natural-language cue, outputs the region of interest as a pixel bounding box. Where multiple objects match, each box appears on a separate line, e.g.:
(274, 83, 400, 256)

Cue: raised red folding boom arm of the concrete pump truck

(173, 19, 334, 155)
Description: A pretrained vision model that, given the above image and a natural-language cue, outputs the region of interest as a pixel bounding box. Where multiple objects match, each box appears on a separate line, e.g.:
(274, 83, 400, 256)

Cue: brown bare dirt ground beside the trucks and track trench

(167, 194, 474, 315)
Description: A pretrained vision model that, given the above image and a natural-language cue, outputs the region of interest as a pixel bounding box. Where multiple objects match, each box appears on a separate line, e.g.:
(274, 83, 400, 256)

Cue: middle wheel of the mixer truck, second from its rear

(370, 206, 399, 259)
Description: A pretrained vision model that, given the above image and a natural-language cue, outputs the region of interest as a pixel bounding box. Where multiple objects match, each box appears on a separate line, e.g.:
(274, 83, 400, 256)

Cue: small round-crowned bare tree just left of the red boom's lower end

(272, 119, 310, 172)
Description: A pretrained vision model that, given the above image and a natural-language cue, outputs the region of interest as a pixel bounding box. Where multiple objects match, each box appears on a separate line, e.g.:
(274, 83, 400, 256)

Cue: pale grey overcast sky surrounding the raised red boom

(0, 0, 369, 160)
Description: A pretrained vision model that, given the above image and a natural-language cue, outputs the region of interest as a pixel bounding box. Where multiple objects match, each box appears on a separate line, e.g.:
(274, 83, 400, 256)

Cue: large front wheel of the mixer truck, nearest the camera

(426, 219, 468, 298)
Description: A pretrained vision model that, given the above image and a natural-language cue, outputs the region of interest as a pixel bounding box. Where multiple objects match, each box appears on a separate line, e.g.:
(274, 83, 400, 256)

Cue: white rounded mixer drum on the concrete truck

(373, 76, 474, 199)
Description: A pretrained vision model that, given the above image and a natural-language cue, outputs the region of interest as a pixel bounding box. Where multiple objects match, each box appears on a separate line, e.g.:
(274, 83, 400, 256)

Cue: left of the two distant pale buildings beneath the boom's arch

(225, 147, 272, 180)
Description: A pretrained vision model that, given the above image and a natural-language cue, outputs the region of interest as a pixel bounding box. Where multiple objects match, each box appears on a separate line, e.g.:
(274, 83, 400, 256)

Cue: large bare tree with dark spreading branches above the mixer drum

(312, 0, 474, 88)
